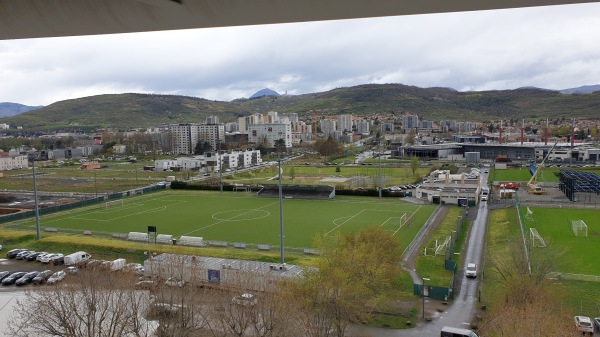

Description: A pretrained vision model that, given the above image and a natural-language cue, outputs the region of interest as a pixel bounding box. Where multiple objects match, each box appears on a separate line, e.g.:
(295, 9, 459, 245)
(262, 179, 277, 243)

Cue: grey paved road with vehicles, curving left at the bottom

(351, 173, 488, 337)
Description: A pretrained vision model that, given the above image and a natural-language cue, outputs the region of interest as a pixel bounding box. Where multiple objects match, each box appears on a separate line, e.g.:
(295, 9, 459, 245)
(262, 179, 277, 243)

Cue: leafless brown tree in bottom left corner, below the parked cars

(9, 270, 155, 337)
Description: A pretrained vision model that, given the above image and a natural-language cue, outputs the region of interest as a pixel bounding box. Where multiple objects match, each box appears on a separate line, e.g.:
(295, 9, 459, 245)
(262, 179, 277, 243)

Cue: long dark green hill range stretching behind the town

(0, 84, 600, 131)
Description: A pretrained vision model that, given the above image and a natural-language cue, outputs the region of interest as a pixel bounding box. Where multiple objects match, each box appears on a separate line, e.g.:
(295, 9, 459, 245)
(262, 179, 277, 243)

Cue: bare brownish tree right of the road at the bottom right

(481, 242, 576, 337)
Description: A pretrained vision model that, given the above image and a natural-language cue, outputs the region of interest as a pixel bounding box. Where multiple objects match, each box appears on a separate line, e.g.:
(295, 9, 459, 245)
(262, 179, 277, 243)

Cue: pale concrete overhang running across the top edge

(0, 0, 597, 40)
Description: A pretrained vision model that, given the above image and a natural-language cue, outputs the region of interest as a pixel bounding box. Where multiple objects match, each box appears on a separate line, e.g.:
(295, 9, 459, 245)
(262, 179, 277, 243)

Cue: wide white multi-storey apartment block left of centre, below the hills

(169, 124, 225, 154)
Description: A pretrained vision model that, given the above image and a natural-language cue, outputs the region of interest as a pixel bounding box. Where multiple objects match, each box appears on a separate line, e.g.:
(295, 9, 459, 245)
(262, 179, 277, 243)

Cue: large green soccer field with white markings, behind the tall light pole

(11, 191, 435, 248)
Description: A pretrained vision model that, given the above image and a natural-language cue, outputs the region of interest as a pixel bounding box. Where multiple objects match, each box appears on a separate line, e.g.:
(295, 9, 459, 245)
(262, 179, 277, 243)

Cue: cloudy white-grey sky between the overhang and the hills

(0, 3, 600, 105)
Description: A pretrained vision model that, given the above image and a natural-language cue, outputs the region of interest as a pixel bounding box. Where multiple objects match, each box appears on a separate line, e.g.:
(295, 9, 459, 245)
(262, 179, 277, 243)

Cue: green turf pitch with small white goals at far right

(521, 207, 600, 275)
